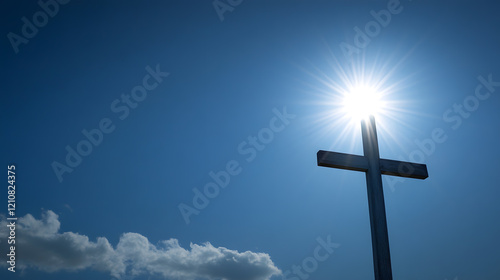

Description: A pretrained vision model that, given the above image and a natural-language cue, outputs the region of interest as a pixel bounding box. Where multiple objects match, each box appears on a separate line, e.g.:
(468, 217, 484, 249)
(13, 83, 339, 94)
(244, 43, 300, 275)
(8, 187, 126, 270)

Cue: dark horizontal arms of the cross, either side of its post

(317, 150, 429, 179)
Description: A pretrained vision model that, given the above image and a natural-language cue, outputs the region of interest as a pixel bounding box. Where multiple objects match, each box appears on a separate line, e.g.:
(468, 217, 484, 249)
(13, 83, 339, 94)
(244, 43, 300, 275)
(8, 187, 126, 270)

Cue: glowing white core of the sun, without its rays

(341, 85, 384, 121)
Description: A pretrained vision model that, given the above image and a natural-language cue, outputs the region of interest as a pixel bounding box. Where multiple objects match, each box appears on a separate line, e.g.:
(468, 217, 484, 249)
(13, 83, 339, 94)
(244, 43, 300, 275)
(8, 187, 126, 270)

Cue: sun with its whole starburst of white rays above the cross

(300, 49, 416, 152)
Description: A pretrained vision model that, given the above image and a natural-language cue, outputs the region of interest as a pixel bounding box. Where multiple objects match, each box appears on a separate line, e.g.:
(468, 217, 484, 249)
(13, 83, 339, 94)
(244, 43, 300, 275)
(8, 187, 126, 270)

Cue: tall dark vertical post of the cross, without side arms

(361, 116, 392, 280)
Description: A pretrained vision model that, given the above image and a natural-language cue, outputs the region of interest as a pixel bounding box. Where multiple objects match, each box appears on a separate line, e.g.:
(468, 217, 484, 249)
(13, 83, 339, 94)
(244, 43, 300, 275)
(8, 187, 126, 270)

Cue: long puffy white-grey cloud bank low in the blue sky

(0, 210, 281, 280)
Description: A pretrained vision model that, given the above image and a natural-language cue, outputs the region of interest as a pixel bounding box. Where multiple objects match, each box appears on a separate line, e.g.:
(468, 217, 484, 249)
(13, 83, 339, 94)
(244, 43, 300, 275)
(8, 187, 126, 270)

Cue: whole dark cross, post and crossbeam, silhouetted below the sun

(317, 116, 429, 280)
